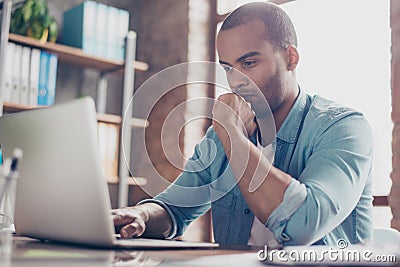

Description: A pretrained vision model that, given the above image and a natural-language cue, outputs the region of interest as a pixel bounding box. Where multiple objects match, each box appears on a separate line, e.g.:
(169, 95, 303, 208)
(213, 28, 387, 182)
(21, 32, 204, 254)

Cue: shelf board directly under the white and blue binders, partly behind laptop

(3, 102, 149, 128)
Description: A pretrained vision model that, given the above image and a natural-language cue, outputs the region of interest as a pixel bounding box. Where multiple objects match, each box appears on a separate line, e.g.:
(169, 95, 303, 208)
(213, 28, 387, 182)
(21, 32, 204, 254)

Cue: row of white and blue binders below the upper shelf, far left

(2, 42, 58, 106)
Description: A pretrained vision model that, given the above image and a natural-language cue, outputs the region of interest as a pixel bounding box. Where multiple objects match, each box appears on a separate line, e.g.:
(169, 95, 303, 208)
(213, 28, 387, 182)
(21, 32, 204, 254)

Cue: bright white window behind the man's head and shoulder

(282, 0, 393, 226)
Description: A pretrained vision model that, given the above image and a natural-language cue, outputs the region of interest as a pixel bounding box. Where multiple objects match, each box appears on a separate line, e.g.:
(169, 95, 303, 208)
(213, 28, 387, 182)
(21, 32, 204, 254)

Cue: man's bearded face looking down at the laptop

(217, 21, 288, 118)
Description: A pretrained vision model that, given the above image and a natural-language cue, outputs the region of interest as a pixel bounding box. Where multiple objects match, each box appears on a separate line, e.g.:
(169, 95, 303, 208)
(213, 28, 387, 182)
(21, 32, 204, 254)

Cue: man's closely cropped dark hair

(221, 2, 297, 48)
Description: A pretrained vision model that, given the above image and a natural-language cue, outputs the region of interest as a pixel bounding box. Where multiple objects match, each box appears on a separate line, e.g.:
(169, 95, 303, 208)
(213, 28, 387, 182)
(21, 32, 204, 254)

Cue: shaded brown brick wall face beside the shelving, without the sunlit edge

(125, 0, 188, 204)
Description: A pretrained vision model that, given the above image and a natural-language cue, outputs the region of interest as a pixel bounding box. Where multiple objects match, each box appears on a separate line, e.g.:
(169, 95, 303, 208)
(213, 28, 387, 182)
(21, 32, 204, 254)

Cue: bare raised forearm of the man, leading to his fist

(216, 126, 291, 223)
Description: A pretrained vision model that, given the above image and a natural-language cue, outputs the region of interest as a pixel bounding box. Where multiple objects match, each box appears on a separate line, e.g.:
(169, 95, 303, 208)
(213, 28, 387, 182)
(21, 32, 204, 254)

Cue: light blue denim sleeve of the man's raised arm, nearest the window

(266, 113, 373, 245)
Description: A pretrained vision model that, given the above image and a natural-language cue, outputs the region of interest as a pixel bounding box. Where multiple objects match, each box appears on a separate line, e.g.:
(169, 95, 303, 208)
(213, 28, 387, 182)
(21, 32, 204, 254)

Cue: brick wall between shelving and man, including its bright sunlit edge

(130, 0, 214, 241)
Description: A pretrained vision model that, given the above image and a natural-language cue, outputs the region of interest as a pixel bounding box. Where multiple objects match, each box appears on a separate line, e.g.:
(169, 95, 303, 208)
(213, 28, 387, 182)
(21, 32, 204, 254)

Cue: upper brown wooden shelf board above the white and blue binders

(9, 33, 149, 72)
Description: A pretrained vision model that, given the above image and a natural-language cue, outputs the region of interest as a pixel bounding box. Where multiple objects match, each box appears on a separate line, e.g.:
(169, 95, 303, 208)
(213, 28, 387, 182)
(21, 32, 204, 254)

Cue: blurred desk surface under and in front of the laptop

(0, 237, 265, 267)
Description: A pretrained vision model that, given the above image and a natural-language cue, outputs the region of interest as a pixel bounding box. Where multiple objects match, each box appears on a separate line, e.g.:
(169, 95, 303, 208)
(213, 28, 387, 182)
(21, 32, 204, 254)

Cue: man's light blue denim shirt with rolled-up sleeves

(141, 91, 373, 245)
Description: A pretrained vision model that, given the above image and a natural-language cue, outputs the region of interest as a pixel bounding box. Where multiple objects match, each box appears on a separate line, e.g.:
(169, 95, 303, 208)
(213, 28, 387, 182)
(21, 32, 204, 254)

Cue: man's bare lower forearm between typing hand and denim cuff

(136, 203, 172, 238)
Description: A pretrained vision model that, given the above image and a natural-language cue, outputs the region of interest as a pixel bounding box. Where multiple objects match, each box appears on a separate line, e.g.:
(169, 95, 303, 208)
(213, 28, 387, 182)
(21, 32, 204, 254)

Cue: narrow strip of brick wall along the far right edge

(389, 0, 400, 230)
